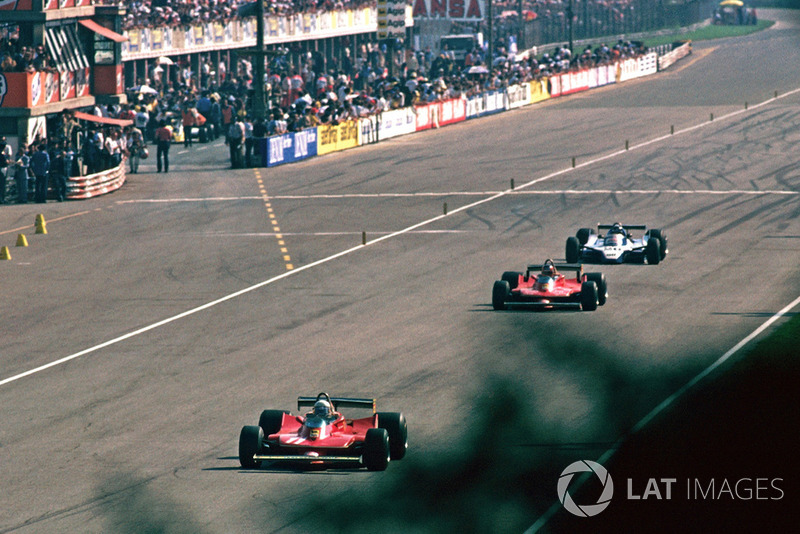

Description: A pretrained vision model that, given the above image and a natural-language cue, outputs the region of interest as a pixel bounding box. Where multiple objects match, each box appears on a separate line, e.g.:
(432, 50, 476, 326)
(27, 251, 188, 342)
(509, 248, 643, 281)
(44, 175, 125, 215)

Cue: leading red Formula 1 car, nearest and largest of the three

(239, 393, 408, 471)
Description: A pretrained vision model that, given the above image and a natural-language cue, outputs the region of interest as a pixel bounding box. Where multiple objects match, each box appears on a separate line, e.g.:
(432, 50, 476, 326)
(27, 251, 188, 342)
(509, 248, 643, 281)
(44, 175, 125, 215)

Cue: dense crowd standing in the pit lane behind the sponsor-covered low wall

(72, 35, 644, 169)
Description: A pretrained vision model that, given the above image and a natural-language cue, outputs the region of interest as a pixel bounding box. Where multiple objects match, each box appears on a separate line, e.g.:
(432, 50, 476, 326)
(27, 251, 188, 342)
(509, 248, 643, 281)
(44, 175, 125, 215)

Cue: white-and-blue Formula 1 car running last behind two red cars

(567, 223, 669, 265)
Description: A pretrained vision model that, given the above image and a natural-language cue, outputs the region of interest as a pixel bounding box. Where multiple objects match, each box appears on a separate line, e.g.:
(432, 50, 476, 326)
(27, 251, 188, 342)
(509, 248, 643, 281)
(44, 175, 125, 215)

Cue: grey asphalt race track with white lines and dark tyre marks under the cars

(0, 10, 800, 533)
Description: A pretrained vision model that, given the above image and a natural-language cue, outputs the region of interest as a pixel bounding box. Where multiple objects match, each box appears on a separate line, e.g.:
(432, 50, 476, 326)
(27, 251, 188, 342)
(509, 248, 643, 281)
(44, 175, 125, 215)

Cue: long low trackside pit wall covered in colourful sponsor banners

(259, 52, 664, 167)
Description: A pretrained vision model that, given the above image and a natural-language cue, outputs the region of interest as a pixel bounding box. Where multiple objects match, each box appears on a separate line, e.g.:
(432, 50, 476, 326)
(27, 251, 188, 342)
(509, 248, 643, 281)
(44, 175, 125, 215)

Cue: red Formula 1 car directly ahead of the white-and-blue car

(492, 260, 608, 311)
